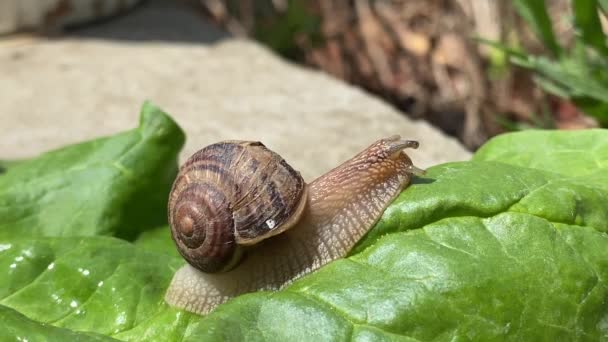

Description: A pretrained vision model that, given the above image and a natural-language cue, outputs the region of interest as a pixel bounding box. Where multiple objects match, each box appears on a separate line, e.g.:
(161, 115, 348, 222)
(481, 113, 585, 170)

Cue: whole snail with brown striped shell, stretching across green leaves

(165, 136, 425, 314)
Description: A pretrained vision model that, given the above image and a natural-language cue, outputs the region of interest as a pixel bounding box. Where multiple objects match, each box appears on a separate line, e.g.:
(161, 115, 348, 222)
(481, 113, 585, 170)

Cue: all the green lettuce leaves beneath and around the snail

(0, 104, 608, 341)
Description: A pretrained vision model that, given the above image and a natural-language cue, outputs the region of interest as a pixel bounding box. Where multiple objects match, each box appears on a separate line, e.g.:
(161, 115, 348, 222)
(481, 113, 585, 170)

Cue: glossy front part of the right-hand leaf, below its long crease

(192, 213, 608, 341)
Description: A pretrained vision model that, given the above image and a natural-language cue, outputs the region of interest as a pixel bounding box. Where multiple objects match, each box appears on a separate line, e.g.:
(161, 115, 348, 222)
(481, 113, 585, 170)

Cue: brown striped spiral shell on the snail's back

(169, 141, 307, 273)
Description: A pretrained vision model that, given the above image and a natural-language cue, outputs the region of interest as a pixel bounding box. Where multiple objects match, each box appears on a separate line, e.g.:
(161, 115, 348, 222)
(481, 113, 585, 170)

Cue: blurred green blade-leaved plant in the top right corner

(494, 0, 608, 127)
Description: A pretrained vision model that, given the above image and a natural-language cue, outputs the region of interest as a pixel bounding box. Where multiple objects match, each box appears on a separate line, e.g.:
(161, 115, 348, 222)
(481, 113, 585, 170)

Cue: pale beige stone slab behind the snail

(0, 2, 470, 180)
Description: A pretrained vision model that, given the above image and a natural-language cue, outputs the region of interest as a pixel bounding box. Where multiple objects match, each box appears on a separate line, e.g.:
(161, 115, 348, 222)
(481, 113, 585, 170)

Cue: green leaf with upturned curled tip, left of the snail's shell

(0, 103, 184, 239)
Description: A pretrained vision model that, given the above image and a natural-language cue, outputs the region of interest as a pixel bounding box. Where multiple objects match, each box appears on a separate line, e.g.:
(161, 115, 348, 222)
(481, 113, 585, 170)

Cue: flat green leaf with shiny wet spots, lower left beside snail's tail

(0, 236, 193, 340)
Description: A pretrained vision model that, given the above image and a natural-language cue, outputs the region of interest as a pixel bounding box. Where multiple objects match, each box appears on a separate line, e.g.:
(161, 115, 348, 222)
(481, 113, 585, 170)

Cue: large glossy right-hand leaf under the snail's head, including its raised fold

(189, 157, 608, 341)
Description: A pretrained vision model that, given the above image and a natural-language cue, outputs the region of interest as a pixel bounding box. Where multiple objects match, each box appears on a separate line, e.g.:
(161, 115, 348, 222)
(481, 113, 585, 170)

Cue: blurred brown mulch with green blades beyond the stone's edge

(197, 0, 608, 149)
